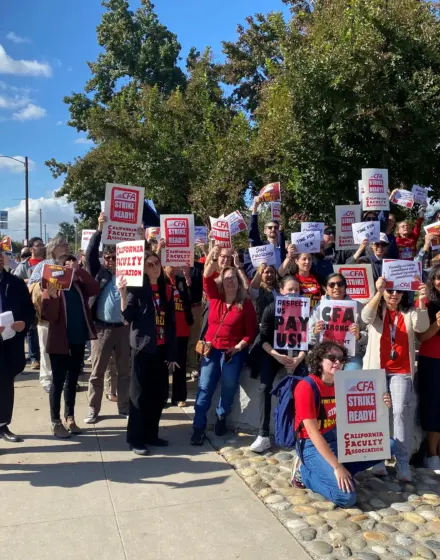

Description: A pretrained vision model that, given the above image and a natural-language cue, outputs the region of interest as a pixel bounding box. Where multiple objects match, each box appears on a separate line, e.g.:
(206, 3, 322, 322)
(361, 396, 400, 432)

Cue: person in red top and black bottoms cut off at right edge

(417, 265, 440, 474)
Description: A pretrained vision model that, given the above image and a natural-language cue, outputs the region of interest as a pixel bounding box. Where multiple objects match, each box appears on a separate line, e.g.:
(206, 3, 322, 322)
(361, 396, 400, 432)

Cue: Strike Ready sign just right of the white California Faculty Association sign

(160, 214, 194, 266)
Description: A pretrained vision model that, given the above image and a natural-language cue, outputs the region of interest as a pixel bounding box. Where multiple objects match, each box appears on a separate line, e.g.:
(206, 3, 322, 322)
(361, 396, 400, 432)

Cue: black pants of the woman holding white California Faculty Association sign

(127, 346, 169, 447)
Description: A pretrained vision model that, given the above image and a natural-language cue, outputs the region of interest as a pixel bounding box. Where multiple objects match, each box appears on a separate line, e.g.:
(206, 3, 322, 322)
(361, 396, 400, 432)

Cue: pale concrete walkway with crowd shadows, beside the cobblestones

(0, 373, 309, 560)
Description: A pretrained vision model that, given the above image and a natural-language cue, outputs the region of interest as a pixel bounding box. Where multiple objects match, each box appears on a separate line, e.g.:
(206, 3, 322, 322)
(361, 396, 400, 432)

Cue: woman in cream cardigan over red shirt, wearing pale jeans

(362, 277, 430, 482)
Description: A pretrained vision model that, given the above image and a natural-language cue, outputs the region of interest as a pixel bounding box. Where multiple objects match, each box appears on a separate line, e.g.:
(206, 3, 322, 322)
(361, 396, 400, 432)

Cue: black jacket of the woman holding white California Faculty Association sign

(122, 277, 177, 362)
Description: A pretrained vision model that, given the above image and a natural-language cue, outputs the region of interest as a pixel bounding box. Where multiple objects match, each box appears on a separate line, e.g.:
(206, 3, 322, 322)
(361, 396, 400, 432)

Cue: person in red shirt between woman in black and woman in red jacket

(164, 266, 194, 407)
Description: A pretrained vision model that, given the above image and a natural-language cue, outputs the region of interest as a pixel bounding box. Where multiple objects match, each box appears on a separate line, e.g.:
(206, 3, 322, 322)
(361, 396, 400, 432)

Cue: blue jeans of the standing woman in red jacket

(193, 348, 248, 430)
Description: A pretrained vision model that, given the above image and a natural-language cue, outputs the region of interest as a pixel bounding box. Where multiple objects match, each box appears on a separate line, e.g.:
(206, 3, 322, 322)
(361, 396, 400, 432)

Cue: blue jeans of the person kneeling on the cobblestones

(298, 430, 398, 507)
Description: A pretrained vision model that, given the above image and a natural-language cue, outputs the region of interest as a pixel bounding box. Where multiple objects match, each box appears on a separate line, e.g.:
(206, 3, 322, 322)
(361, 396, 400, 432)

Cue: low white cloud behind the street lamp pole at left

(5, 197, 74, 241)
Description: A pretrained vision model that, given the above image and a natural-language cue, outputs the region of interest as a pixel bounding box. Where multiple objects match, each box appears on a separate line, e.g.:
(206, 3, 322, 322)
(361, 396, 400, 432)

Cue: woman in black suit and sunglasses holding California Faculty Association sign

(118, 251, 179, 456)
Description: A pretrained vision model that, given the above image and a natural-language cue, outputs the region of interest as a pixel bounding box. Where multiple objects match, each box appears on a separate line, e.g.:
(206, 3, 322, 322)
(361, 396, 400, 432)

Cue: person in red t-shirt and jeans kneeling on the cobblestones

(292, 342, 391, 507)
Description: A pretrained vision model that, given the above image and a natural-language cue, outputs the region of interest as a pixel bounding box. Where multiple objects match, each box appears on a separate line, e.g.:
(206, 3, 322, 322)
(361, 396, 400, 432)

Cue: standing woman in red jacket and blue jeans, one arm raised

(191, 249, 257, 445)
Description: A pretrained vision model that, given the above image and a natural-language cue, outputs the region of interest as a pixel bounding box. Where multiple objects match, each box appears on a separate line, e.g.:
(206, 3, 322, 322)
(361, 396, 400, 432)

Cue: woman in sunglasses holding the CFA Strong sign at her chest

(309, 273, 367, 370)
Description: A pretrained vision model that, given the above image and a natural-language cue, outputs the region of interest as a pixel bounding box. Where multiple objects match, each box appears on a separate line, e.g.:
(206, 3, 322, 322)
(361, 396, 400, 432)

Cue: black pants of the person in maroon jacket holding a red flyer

(49, 344, 85, 422)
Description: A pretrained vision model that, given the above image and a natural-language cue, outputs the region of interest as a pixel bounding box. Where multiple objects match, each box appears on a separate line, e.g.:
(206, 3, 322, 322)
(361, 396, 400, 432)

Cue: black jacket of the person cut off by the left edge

(0, 270, 35, 375)
